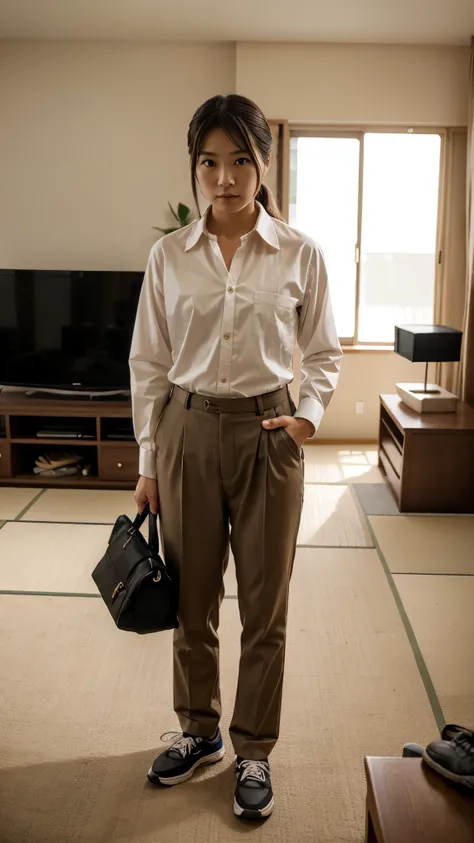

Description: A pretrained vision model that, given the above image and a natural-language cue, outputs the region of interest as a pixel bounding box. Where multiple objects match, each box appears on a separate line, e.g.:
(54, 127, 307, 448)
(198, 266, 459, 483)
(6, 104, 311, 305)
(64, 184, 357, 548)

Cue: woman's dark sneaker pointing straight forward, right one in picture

(234, 758, 274, 820)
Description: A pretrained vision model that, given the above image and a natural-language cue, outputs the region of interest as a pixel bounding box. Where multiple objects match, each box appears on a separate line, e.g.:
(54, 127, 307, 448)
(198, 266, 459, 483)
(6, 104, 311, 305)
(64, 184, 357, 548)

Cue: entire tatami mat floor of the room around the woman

(0, 446, 474, 843)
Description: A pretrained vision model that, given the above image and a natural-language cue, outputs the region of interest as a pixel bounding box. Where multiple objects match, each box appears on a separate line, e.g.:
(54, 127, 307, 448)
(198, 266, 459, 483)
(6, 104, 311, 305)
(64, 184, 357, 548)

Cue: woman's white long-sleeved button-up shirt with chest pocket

(130, 205, 342, 477)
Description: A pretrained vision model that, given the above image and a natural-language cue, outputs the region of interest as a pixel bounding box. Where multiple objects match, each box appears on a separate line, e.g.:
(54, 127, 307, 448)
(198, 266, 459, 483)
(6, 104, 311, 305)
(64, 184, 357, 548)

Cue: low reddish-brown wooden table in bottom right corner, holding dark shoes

(365, 758, 474, 843)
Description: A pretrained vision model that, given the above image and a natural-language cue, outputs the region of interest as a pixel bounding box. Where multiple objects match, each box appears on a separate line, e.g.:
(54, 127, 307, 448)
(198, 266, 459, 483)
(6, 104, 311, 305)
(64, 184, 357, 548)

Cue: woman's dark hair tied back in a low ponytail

(188, 94, 283, 220)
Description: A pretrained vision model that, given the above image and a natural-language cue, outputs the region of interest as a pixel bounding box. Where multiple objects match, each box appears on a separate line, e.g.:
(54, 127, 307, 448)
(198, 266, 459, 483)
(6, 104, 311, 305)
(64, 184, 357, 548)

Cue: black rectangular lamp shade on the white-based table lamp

(395, 325, 462, 363)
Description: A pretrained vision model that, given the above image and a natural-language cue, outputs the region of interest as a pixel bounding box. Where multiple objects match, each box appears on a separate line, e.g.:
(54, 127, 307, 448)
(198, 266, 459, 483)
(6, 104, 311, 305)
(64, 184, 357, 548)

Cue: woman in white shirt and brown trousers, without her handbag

(130, 90, 341, 819)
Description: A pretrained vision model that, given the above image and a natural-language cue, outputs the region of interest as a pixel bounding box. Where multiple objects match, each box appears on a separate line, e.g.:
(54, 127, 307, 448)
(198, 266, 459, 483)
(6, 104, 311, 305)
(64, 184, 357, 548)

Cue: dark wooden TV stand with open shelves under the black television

(0, 389, 138, 489)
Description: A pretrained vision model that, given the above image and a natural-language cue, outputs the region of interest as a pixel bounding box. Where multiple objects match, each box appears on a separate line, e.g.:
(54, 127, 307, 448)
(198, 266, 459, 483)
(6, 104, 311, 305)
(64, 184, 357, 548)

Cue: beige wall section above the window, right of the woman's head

(237, 44, 469, 126)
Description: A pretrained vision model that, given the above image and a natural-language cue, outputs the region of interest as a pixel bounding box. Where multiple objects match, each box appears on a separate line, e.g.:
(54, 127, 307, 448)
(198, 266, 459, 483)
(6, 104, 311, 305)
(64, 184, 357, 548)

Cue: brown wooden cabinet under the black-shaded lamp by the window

(379, 395, 474, 516)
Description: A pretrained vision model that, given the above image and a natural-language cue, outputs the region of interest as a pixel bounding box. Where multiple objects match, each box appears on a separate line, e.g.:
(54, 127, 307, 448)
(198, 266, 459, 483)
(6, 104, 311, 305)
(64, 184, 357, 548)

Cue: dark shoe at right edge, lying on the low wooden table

(423, 729, 474, 787)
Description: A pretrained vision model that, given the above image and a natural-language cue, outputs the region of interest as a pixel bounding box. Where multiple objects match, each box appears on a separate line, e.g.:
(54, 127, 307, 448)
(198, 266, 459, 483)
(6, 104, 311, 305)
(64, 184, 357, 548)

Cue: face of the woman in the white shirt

(196, 129, 268, 214)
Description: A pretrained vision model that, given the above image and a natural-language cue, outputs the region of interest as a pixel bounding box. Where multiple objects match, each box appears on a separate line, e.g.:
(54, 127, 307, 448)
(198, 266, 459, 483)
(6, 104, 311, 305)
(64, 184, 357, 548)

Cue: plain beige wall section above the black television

(0, 41, 235, 270)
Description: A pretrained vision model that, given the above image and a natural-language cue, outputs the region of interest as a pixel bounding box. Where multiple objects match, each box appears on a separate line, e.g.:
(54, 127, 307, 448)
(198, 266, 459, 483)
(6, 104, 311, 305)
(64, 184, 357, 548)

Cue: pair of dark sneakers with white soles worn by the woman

(148, 729, 274, 820)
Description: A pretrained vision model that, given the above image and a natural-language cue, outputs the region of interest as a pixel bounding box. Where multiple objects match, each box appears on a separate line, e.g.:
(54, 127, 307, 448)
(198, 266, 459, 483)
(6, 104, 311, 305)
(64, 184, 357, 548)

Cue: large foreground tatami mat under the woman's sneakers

(0, 548, 436, 843)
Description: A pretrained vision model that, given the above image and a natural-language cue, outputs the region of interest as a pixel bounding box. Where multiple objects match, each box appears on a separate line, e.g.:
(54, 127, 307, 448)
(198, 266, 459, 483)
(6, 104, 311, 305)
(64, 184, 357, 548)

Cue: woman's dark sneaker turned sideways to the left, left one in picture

(148, 729, 225, 786)
